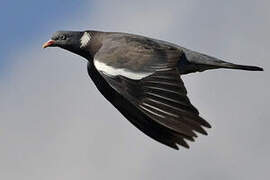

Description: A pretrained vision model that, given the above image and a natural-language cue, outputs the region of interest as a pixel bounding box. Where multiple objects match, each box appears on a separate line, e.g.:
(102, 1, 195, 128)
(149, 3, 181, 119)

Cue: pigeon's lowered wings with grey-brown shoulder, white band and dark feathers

(88, 33, 210, 149)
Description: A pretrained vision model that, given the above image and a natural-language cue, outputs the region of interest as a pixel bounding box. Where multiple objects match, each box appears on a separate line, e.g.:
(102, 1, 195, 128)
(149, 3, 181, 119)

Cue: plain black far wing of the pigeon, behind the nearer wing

(87, 63, 185, 150)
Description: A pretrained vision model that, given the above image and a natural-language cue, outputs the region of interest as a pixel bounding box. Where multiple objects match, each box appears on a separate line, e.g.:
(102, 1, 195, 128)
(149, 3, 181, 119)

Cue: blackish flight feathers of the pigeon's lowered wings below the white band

(88, 64, 211, 149)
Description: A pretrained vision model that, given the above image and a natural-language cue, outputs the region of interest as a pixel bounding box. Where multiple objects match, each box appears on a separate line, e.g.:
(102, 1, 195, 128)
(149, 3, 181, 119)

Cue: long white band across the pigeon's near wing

(94, 59, 152, 80)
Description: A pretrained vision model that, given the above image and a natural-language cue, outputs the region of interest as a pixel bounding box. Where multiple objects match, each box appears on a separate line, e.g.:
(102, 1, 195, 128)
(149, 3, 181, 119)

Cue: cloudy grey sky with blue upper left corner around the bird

(0, 0, 270, 180)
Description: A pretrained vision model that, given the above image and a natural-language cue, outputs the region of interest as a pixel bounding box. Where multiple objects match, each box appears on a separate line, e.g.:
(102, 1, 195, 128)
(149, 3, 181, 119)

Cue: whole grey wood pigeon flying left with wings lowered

(43, 31, 263, 149)
